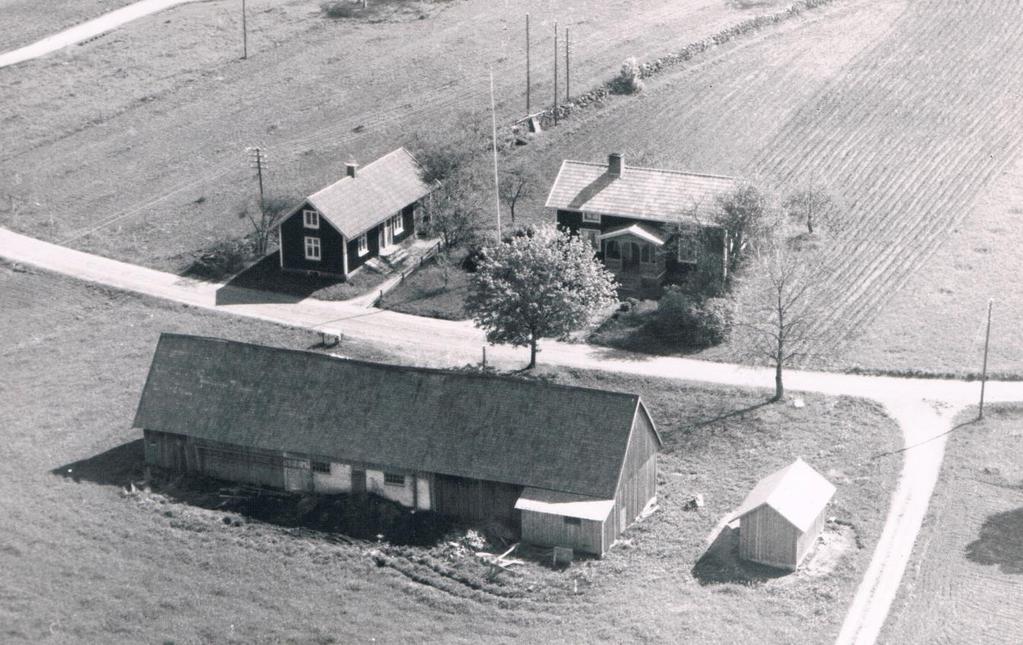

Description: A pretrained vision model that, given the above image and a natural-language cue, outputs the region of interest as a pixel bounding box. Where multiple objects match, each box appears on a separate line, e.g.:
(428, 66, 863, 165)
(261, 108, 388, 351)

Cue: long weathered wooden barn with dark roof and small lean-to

(134, 334, 661, 555)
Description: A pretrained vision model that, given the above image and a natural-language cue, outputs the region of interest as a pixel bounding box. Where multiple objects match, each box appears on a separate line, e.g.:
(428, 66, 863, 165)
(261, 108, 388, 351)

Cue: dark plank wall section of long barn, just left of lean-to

(433, 475, 523, 526)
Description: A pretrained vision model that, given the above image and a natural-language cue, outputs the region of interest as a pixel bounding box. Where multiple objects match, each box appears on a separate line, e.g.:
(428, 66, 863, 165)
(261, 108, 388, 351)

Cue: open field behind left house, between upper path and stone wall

(0, 0, 777, 270)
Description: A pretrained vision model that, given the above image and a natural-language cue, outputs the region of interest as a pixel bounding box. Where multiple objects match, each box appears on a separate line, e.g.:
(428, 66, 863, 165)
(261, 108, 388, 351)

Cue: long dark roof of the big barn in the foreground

(134, 334, 642, 499)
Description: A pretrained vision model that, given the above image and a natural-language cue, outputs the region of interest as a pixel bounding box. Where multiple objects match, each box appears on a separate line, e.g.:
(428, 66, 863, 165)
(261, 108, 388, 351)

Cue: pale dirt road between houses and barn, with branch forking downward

(0, 228, 1023, 644)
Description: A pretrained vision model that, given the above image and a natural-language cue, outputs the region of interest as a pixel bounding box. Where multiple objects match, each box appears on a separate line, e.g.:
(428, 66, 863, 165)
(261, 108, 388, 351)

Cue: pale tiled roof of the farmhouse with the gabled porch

(546, 155, 737, 222)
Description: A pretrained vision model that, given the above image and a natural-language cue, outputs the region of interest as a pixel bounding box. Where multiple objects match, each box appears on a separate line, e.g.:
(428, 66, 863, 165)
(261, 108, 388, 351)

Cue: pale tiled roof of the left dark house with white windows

(306, 147, 430, 240)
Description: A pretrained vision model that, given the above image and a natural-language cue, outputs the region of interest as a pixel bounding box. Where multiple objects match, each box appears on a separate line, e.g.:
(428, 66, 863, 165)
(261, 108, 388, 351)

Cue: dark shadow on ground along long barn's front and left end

(50, 439, 468, 547)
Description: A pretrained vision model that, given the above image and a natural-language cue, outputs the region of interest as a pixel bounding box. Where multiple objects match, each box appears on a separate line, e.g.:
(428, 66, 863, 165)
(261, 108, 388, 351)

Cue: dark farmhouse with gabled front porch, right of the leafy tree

(546, 154, 737, 297)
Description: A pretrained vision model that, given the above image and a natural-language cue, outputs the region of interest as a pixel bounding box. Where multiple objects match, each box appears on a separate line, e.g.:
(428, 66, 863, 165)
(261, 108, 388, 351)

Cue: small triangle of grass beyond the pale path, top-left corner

(0, 0, 135, 52)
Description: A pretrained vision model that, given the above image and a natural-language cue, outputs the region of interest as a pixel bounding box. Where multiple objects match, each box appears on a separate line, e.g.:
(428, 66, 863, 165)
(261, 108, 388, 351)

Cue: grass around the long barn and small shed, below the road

(0, 265, 899, 643)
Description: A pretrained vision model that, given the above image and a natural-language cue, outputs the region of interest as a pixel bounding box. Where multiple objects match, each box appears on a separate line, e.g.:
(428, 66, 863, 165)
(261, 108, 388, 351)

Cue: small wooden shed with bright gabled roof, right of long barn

(732, 459, 835, 571)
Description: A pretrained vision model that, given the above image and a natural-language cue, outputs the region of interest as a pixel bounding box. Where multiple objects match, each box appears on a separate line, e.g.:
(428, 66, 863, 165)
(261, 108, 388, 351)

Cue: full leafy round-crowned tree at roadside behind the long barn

(465, 224, 616, 369)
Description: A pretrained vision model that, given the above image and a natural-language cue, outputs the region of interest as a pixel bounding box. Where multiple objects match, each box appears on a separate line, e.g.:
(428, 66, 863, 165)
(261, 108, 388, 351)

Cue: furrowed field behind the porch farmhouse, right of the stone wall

(511, 0, 1023, 369)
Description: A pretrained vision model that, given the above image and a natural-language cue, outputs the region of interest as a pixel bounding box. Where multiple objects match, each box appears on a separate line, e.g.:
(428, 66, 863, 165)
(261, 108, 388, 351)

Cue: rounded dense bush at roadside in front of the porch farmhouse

(651, 286, 731, 347)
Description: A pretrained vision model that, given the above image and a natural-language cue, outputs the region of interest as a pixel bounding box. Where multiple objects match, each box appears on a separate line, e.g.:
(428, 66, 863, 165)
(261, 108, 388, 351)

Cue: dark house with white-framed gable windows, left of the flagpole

(279, 147, 430, 278)
